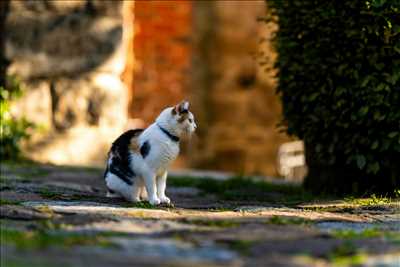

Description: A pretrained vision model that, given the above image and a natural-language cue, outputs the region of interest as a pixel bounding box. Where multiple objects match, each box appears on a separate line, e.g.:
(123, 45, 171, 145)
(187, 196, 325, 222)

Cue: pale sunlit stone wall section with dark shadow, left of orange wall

(6, 1, 127, 165)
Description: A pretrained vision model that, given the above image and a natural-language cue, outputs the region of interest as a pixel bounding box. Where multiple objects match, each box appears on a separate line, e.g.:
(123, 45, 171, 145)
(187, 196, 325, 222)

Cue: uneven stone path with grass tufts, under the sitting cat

(0, 164, 400, 267)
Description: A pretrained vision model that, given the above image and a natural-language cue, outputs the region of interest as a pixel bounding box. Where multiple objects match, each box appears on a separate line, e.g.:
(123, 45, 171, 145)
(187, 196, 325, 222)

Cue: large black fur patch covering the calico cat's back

(106, 129, 143, 185)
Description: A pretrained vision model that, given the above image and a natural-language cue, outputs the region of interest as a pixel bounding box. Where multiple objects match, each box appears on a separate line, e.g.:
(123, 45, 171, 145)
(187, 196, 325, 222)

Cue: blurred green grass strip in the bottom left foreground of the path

(0, 228, 111, 250)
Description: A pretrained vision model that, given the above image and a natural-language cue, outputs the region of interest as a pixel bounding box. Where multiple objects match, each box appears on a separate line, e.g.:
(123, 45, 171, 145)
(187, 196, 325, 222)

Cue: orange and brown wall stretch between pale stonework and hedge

(126, 0, 287, 175)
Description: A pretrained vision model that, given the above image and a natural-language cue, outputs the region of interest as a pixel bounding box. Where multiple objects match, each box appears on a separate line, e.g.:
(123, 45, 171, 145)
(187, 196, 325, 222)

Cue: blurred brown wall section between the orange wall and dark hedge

(193, 1, 285, 175)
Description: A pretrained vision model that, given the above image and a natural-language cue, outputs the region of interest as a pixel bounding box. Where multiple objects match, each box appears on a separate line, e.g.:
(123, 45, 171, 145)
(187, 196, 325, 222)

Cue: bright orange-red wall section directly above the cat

(129, 1, 192, 123)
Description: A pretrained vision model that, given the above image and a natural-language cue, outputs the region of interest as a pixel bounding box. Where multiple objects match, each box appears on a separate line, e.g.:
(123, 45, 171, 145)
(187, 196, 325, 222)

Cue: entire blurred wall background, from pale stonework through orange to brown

(1, 0, 304, 182)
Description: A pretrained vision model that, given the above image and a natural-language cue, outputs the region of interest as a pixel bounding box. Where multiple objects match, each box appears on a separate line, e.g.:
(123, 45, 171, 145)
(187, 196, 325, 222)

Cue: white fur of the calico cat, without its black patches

(106, 102, 197, 205)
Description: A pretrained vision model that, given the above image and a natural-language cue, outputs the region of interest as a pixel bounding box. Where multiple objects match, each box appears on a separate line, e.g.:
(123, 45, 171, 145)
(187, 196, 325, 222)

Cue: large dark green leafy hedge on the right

(267, 0, 400, 193)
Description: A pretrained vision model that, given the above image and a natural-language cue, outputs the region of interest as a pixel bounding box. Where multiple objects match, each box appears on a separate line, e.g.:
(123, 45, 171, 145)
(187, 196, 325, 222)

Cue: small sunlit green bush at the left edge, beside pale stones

(0, 76, 33, 160)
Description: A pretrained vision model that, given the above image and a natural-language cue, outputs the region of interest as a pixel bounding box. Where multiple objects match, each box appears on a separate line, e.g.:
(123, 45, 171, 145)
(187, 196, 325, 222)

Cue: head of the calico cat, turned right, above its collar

(156, 101, 197, 136)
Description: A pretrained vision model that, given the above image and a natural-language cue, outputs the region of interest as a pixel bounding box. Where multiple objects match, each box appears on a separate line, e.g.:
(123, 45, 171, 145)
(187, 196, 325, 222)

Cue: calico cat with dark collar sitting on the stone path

(104, 101, 197, 205)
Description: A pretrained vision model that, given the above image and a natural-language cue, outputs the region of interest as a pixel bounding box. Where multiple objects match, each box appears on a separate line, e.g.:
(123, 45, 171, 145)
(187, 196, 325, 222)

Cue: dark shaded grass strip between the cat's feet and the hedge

(168, 177, 313, 205)
